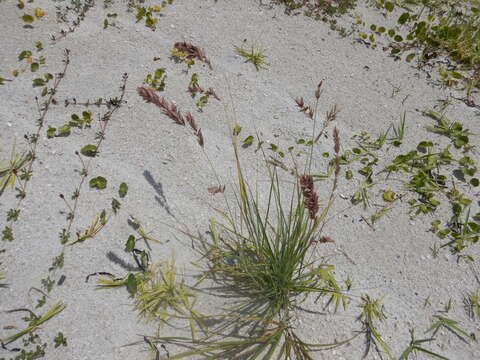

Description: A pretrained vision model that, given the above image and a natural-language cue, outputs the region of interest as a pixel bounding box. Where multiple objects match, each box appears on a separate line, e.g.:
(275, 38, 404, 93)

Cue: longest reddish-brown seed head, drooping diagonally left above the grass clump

(137, 86, 205, 147)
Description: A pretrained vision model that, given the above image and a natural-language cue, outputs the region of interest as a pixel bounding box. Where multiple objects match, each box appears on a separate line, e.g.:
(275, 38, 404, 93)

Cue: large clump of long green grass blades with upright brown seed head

(149, 85, 352, 359)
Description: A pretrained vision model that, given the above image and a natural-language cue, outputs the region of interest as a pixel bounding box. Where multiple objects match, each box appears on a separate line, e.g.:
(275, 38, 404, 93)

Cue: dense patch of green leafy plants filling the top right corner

(364, 0, 480, 100)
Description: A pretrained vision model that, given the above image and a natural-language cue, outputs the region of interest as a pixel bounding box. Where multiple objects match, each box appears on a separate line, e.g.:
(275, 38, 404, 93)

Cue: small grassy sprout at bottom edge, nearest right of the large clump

(359, 295, 395, 360)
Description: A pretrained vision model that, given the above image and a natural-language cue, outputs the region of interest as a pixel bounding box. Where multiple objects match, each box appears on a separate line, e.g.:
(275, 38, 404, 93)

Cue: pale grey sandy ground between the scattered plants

(0, 0, 480, 360)
